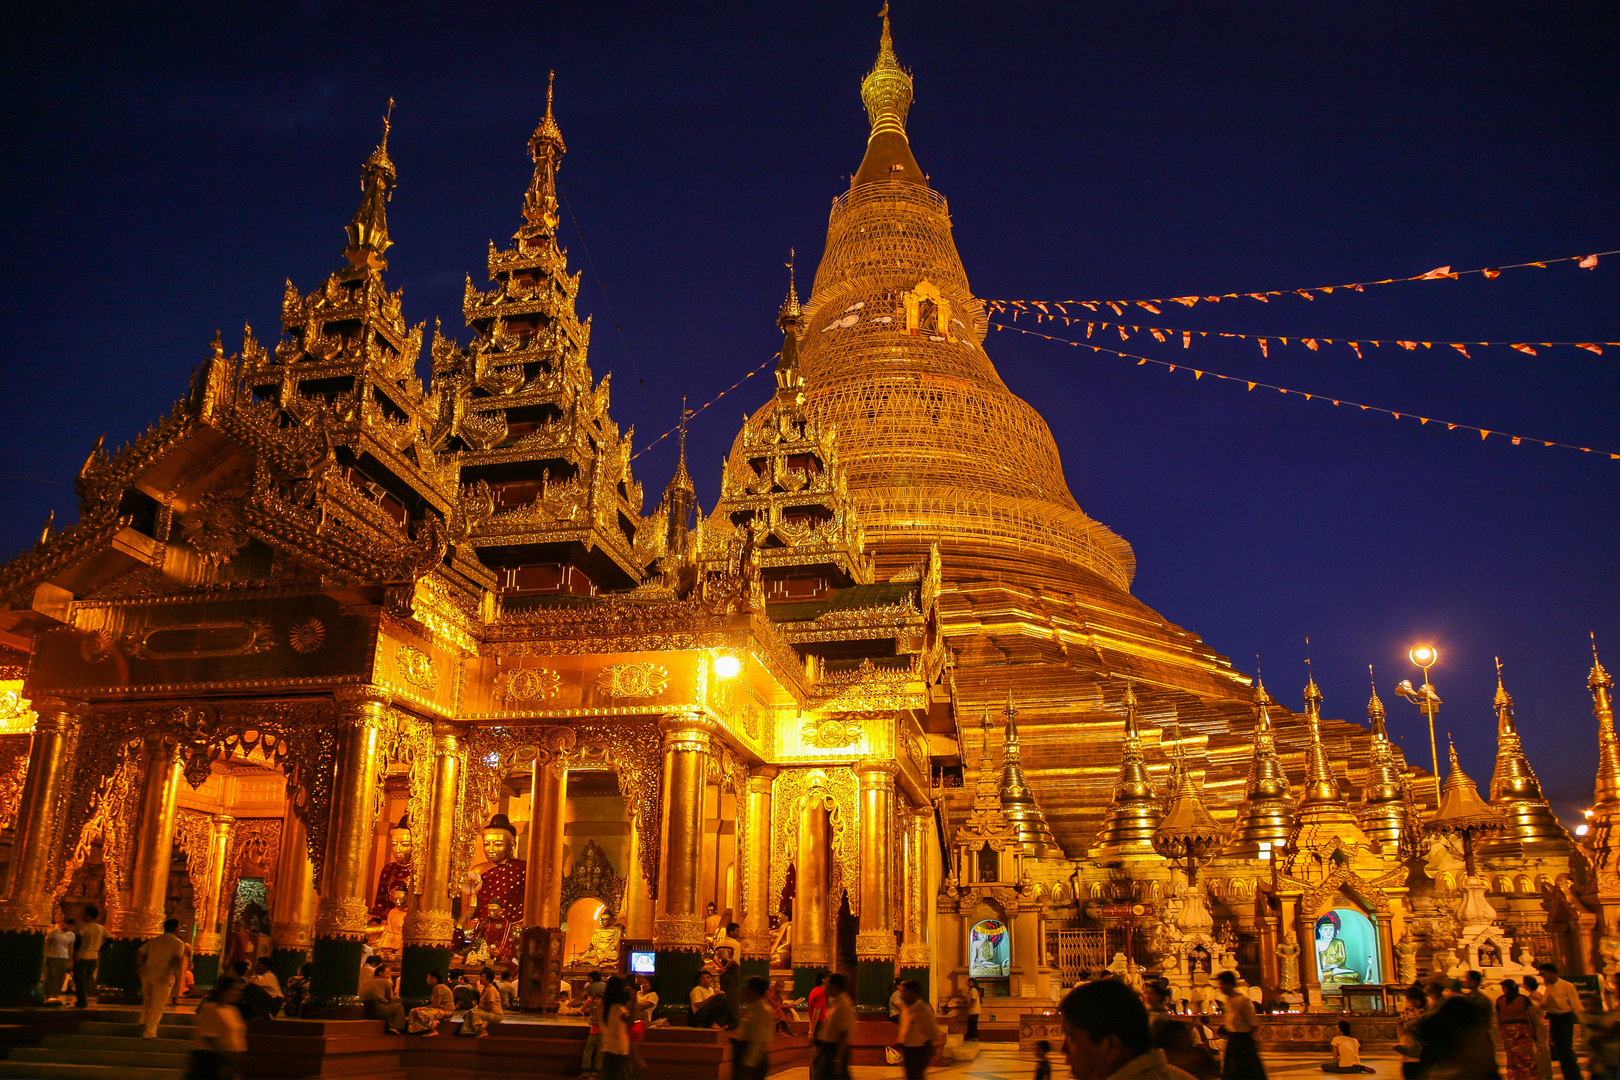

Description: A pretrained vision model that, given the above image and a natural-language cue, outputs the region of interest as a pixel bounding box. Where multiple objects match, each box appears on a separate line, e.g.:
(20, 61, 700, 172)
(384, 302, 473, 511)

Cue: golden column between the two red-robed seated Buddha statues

(400, 724, 463, 1004)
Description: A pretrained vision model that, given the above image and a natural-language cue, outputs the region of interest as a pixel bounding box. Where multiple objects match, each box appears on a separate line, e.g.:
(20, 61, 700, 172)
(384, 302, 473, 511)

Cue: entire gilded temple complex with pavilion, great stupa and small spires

(0, 15, 1620, 1029)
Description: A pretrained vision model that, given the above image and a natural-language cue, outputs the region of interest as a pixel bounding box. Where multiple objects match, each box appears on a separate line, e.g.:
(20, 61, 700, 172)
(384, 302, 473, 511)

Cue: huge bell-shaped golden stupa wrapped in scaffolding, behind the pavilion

(799, 6, 1399, 852)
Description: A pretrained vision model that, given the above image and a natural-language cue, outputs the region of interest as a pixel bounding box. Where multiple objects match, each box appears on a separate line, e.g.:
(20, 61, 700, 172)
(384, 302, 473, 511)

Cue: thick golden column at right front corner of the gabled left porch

(309, 685, 392, 1017)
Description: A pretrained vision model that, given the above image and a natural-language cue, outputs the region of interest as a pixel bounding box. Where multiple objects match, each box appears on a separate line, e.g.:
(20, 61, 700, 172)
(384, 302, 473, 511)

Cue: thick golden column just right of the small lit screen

(653, 714, 714, 1001)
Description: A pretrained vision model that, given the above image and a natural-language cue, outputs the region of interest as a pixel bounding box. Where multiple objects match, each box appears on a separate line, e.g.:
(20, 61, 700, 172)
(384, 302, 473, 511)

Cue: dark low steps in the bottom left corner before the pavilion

(0, 1009, 194, 1080)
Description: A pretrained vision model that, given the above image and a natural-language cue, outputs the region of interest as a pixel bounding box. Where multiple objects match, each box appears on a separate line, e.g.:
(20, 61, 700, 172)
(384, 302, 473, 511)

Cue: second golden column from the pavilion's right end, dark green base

(855, 758, 901, 1014)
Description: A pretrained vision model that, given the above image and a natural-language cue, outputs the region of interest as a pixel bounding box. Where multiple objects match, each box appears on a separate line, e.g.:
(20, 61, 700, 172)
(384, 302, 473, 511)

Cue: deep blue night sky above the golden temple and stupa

(0, 0, 1620, 818)
